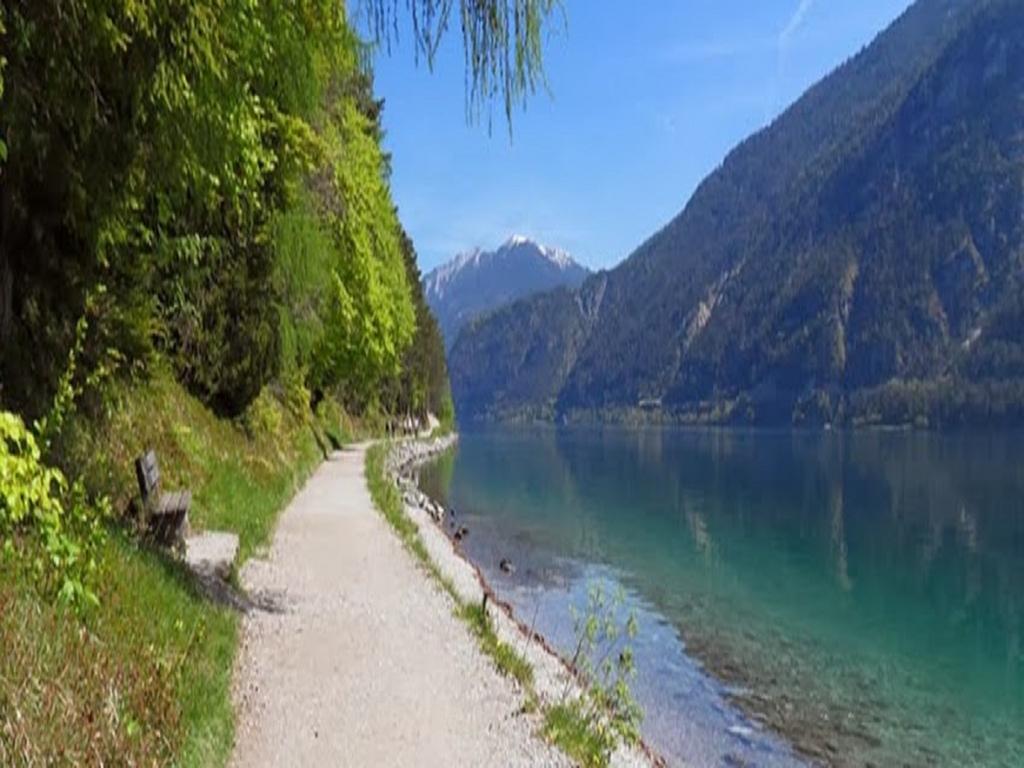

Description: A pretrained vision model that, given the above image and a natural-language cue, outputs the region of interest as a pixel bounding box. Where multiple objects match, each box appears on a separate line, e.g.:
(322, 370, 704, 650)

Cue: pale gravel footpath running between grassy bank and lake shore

(232, 446, 565, 768)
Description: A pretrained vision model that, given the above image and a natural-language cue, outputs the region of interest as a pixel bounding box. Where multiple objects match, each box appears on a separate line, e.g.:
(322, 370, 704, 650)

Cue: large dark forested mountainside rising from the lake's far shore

(449, 0, 1024, 426)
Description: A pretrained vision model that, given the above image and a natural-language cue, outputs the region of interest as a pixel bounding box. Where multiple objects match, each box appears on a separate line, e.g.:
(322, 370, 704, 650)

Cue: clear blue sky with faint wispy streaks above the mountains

(360, 0, 909, 271)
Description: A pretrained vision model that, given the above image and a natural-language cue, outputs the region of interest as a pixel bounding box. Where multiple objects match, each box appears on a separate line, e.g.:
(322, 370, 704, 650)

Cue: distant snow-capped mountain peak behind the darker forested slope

(423, 234, 590, 347)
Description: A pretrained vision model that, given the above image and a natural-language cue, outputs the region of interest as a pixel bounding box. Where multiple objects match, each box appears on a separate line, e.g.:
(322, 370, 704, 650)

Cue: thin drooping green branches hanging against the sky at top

(361, 0, 562, 125)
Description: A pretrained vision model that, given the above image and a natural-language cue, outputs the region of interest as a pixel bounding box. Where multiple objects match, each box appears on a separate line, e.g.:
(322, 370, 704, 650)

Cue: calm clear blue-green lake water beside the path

(421, 428, 1024, 767)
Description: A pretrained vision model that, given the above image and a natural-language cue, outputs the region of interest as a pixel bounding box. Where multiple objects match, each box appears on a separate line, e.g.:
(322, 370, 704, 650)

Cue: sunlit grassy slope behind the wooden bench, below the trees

(61, 374, 326, 562)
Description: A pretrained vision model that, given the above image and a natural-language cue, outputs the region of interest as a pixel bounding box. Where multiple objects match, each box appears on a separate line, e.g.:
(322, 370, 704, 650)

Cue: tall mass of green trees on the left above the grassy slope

(0, 0, 448, 418)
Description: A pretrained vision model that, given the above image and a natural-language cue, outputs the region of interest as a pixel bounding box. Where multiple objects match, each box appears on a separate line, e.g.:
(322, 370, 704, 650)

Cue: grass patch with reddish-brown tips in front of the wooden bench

(0, 532, 238, 766)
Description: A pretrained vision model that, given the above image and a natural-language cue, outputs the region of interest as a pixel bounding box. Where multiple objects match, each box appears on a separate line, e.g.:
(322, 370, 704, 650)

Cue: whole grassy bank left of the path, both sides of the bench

(0, 375, 343, 768)
